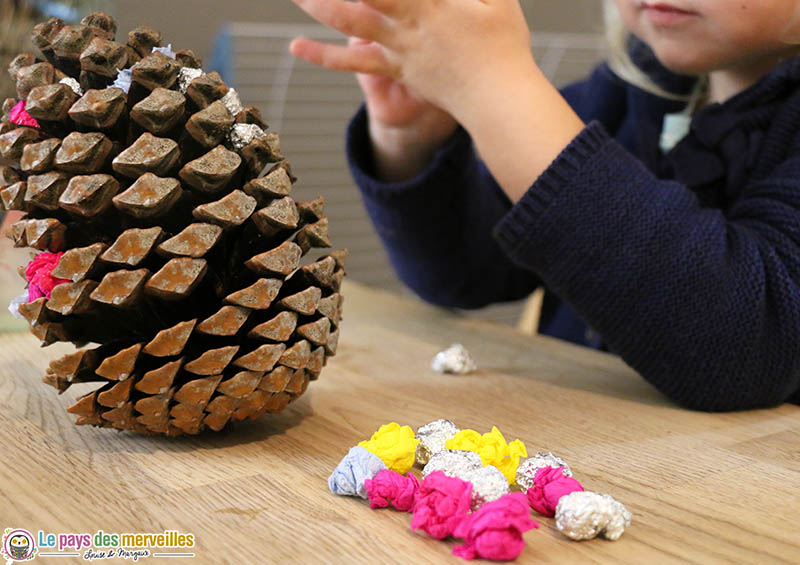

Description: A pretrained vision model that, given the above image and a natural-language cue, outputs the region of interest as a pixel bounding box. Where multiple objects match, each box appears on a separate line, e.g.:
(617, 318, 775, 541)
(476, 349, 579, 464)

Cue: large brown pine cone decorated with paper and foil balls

(0, 13, 347, 435)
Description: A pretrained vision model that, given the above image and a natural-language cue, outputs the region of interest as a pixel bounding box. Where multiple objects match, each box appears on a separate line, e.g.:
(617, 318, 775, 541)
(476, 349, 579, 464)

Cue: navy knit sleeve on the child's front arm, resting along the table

(495, 123, 800, 410)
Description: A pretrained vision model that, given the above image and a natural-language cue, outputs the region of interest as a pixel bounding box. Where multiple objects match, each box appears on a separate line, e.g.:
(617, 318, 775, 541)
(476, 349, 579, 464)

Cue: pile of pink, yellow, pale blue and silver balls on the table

(328, 420, 631, 561)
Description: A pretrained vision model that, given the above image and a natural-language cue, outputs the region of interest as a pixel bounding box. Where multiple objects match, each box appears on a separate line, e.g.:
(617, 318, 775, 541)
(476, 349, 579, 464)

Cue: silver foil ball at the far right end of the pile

(556, 491, 631, 541)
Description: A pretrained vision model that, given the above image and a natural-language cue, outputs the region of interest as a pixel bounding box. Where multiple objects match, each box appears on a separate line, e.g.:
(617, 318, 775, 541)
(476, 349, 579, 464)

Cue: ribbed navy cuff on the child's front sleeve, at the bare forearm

(494, 121, 611, 259)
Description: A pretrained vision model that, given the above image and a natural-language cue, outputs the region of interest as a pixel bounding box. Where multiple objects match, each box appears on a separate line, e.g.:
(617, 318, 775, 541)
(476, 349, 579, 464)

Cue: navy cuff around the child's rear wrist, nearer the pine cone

(346, 104, 472, 199)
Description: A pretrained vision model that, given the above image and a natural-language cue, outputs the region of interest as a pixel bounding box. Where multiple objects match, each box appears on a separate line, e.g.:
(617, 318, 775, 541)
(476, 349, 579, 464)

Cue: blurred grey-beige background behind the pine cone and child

(0, 0, 603, 331)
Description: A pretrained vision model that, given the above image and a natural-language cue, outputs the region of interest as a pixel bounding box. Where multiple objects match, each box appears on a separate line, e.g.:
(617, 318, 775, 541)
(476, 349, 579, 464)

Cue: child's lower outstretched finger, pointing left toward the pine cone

(289, 37, 396, 76)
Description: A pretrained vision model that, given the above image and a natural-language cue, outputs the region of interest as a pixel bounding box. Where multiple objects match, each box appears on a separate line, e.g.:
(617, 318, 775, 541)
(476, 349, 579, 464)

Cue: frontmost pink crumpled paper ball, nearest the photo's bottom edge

(453, 492, 539, 561)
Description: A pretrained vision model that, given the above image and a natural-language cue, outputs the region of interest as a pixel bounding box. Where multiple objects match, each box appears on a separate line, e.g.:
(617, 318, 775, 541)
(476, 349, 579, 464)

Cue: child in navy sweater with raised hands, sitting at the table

(291, 0, 800, 410)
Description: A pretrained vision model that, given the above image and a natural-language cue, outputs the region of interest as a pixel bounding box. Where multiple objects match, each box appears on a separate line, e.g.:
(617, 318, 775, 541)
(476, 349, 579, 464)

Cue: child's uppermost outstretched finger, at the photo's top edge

(292, 0, 391, 43)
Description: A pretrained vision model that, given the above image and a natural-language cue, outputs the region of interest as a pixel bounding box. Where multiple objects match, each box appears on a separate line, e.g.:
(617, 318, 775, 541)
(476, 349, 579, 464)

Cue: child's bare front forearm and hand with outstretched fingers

(291, 0, 583, 202)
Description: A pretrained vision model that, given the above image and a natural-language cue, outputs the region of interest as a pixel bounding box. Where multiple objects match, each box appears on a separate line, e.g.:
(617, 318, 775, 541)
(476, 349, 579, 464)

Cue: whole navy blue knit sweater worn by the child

(347, 53, 800, 410)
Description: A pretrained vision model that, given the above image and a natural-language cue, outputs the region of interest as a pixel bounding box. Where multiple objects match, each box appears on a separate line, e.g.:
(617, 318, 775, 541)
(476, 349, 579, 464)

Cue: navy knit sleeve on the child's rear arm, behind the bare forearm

(347, 65, 625, 308)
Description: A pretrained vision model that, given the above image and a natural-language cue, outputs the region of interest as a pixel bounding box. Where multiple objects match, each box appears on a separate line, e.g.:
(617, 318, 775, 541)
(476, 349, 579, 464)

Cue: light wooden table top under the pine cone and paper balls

(0, 283, 800, 564)
